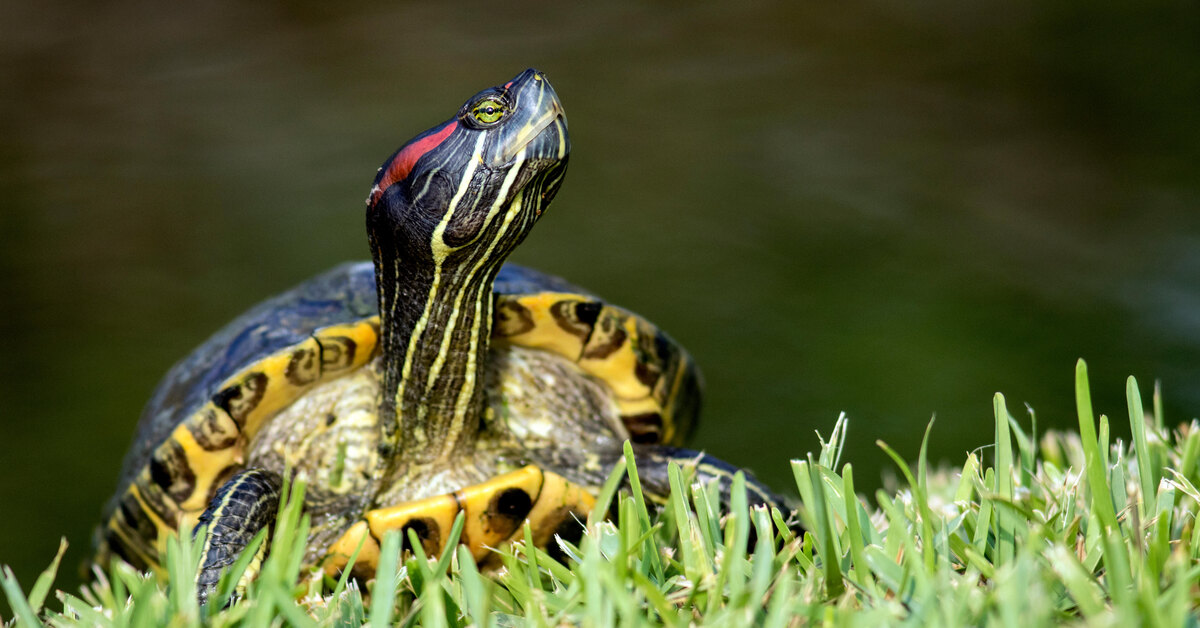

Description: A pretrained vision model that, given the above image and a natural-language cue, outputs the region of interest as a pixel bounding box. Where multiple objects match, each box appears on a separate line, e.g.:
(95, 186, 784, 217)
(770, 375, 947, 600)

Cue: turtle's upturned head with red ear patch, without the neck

(367, 70, 570, 268)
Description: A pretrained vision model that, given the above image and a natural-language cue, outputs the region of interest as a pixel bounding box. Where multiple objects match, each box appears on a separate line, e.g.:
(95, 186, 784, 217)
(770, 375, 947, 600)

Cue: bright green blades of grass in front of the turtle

(0, 361, 1200, 628)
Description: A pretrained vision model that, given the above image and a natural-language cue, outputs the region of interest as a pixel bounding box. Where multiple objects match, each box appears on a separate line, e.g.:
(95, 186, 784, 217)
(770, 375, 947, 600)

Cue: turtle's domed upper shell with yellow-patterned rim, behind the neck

(106, 262, 701, 563)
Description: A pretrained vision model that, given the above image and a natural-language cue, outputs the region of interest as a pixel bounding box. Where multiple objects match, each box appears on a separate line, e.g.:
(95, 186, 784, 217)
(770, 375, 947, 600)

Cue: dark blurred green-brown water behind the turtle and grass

(0, 0, 1200, 600)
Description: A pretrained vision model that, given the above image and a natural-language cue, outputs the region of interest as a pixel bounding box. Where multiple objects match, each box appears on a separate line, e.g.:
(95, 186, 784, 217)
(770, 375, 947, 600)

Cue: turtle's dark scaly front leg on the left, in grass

(196, 468, 281, 605)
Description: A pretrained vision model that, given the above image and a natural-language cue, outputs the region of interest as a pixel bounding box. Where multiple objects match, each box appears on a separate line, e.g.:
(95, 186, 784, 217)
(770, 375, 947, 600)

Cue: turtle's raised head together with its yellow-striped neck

(367, 70, 570, 463)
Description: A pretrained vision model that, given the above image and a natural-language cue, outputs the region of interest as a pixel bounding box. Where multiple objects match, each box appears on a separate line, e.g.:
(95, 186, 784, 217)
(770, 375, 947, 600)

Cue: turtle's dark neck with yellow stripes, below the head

(373, 243, 500, 466)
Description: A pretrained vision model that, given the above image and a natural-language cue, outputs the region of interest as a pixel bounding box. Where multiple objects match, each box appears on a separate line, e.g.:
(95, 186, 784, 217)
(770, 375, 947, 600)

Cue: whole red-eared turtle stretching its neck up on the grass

(95, 68, 784, 603)
